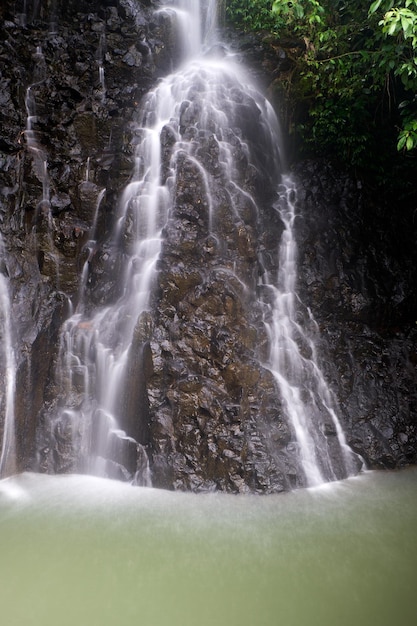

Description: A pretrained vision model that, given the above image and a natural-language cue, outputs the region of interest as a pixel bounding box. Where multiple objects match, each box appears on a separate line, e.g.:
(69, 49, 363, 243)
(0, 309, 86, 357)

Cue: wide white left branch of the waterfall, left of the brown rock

(43, 2, 223, 484)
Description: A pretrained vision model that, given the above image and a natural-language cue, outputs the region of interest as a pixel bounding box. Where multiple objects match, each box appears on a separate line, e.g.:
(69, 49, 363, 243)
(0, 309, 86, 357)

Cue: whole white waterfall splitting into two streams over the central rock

(35, 0, 360, 485)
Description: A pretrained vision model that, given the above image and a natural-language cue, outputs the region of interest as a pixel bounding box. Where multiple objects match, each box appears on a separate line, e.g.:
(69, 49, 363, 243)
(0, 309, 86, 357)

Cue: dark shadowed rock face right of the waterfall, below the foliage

(296, 162, 417, 468)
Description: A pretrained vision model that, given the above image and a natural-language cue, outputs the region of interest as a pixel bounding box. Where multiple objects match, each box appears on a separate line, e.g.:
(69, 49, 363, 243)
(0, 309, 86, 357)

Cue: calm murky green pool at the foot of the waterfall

(0, 469, 417, 626)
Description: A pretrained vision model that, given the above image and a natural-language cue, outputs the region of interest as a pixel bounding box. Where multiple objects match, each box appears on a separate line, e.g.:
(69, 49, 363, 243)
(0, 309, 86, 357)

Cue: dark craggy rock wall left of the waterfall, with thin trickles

(0, 0, 175, 468)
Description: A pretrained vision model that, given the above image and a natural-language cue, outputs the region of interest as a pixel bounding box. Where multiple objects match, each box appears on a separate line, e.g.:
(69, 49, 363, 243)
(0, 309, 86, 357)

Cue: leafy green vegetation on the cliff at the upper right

(226, 0, 417, 195)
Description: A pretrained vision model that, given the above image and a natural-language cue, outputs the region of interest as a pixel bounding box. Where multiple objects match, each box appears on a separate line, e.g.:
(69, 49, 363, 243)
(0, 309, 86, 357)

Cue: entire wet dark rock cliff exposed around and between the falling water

(0, 0, 417, 492)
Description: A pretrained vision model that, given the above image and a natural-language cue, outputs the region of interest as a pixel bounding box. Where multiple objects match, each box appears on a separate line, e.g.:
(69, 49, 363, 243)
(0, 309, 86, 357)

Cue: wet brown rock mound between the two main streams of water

(144, 87, 291, 492)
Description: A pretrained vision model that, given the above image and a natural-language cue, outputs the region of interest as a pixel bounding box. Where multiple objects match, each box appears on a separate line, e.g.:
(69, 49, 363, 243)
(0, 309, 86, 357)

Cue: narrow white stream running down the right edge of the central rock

(264, 176, 358, 487)
